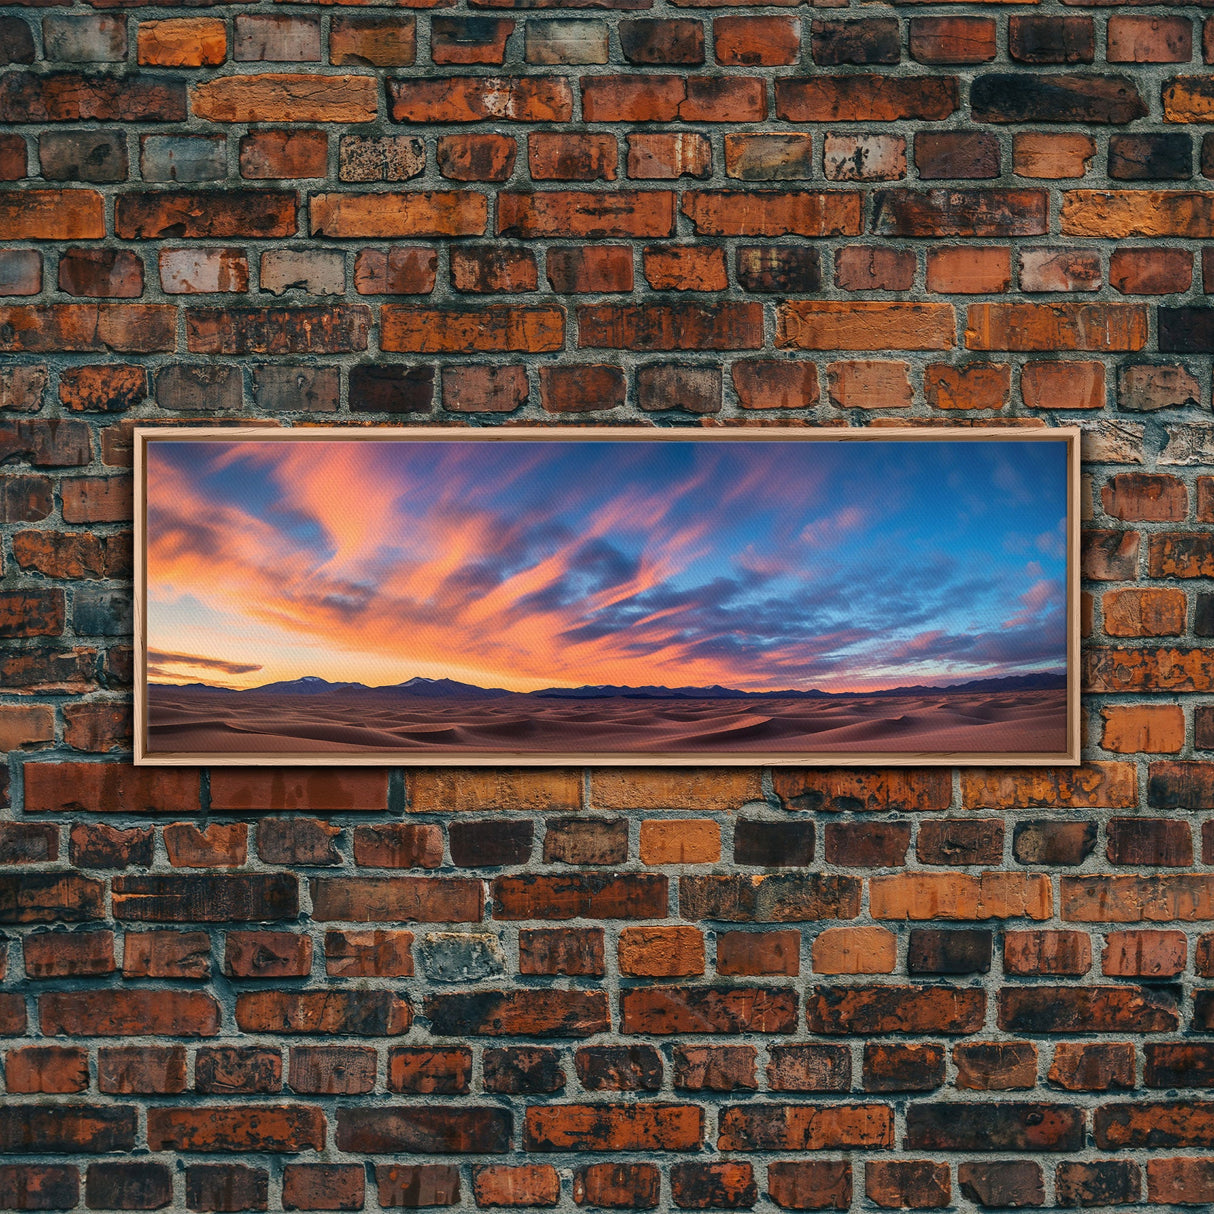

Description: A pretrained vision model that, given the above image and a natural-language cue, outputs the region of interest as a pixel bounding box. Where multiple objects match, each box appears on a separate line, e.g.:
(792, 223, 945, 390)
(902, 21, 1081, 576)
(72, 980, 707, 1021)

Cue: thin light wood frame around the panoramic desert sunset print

(134, 425, 1080, 767)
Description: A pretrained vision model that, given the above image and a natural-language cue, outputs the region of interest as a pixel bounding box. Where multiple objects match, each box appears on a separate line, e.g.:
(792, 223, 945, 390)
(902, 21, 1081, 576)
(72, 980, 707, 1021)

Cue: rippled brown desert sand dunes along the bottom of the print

(148, 686, 1066, 756)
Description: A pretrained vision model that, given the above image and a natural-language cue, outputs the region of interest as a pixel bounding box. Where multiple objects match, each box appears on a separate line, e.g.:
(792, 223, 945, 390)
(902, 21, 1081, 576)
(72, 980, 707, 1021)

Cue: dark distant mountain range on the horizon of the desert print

(151, 673, 1066, 699)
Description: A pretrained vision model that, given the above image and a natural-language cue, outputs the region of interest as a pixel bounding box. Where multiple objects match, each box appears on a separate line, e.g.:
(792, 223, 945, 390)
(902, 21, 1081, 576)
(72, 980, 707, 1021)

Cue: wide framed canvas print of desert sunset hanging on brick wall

(135, 427, 1079, 766)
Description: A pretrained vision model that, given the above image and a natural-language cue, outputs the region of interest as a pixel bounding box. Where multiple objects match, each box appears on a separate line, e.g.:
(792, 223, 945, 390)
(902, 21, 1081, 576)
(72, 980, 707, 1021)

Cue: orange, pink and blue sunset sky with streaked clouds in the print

(147, 439, 1066, 691)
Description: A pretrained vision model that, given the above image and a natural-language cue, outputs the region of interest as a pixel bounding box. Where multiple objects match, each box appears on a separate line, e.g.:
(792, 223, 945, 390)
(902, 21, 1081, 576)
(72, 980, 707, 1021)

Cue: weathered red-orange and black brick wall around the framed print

(0, 0, 1214, 1212)
